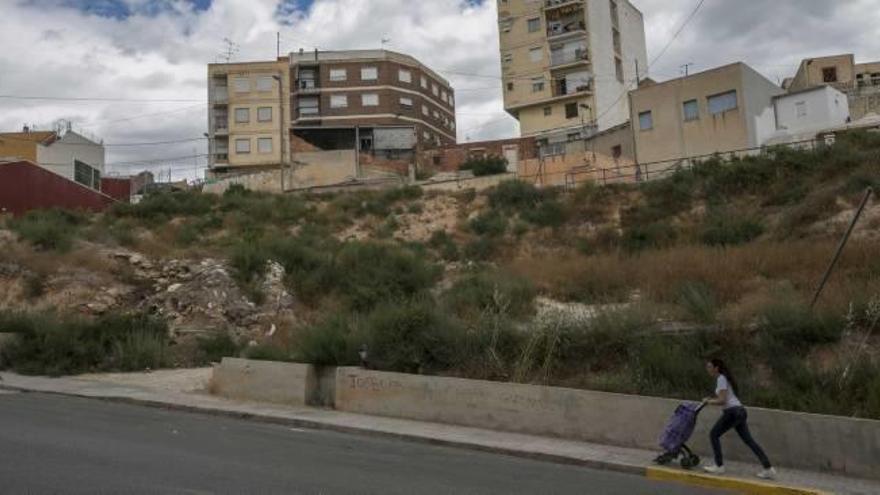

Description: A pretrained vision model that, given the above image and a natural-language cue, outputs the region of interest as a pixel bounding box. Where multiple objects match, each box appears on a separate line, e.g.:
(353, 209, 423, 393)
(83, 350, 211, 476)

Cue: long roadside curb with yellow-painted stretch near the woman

(0, 382, 830, 495)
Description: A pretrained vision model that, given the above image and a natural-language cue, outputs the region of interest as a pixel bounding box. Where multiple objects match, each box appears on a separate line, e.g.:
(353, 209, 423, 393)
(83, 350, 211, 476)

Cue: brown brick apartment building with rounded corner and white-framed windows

(290, 50, 456, 152)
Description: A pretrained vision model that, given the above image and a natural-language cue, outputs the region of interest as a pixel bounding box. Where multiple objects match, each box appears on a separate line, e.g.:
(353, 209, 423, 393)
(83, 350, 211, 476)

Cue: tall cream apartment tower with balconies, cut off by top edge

(498, 0, 647, 143)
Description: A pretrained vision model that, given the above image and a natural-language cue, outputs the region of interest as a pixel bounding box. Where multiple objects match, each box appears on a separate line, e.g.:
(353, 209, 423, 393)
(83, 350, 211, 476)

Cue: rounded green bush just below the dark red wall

(9, 210, 85, 251)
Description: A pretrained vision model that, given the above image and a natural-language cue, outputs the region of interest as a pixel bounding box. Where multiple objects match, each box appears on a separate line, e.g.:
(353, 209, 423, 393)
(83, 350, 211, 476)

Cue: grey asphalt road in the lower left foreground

(0, 393, 714, 495)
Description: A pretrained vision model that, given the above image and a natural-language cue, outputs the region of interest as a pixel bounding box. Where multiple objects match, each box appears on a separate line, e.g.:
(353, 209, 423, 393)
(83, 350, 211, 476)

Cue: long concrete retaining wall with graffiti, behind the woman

(335, 368, 880, 478)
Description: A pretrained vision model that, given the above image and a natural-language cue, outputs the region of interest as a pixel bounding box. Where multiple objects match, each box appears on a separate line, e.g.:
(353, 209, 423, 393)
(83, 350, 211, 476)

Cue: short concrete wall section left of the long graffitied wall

(210, 358, 317, 406)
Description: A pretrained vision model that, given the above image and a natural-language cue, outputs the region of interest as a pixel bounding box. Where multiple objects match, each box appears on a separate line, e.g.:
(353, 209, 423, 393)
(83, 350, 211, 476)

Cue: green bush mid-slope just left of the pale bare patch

(443, 270, 535, 319)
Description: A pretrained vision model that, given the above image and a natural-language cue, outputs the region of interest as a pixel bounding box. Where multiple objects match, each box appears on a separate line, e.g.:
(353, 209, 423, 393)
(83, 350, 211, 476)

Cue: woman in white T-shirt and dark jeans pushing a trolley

(703, 359, 776, 479)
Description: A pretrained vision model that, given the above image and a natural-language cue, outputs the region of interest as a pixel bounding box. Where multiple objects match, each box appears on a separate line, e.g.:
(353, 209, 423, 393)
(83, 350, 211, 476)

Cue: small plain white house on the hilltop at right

(765, 85, 850, 144)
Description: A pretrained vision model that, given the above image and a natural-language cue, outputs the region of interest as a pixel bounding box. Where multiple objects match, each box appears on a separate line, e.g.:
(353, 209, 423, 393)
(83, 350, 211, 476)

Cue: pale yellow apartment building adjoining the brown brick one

(208, 57, 290, 175)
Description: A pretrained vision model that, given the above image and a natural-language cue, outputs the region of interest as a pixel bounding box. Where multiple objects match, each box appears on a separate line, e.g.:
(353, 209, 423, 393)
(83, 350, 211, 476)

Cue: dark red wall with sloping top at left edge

(0, 162, 115, 215)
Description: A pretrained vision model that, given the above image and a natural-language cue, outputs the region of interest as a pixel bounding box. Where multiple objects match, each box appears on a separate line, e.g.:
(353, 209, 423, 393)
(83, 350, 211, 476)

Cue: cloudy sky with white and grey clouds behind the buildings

(0, 0, 880, 177)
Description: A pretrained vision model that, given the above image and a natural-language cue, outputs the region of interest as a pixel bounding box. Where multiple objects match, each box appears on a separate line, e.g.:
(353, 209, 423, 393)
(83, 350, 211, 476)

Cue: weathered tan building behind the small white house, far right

(783, 53, 880, 120)
